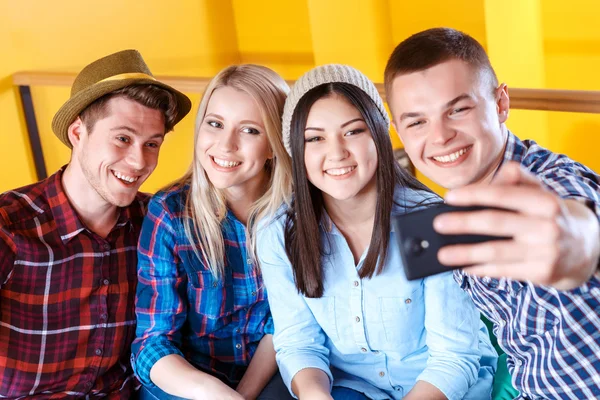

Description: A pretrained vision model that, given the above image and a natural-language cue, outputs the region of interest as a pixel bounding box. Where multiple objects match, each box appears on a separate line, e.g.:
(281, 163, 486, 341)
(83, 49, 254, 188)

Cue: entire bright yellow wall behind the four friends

(0, 0, 600, 197)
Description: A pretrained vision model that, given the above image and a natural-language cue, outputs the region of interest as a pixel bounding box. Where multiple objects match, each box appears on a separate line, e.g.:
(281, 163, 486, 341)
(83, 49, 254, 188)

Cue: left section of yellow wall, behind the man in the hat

(0, 0, 239, 192)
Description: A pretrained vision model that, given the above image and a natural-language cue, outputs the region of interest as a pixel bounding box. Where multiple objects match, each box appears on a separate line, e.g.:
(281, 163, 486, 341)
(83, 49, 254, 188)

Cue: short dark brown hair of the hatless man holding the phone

(384, 28, 498, 98)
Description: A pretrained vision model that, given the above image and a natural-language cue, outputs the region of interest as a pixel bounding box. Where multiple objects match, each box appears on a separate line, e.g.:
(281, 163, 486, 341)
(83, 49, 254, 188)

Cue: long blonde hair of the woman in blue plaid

(174, 64, 292, 277)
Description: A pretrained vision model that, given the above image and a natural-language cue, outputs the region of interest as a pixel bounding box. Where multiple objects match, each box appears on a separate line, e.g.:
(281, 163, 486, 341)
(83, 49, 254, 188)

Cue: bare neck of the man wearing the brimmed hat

(62, 164, 119, 237)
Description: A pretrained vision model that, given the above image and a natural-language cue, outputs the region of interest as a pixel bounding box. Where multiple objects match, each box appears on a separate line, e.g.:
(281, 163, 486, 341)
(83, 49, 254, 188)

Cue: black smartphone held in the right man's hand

(392, 204, 510, 281)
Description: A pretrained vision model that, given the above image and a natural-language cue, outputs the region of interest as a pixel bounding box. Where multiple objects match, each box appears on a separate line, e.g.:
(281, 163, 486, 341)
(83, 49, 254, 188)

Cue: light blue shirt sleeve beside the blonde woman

(256, 217, 333, 397)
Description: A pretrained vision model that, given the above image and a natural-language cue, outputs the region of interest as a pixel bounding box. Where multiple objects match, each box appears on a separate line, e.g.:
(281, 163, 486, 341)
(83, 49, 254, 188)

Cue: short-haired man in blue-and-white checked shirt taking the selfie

(385, 28, 600, 399)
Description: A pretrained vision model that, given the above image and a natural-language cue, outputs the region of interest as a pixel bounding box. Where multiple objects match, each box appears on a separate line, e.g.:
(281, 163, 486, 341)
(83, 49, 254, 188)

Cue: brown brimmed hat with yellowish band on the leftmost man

(52, 50, 192, 148)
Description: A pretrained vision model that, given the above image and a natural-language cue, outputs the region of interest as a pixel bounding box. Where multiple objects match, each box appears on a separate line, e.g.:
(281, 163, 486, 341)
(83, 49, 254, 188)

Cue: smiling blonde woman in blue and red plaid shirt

(132, 65, 291, 400)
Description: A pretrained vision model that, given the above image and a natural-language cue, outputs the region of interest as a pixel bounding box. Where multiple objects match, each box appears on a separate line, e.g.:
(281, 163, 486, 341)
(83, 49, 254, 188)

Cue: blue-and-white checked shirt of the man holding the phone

(455, 132, 600, 400)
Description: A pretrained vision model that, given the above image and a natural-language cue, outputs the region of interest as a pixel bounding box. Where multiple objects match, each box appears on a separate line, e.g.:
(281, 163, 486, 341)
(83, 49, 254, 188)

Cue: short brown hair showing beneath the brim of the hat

(79, 85, 177, 133)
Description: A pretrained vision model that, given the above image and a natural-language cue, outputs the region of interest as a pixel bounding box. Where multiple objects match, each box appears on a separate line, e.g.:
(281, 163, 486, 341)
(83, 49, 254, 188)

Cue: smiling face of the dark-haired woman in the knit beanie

(304, 94, 378, 205)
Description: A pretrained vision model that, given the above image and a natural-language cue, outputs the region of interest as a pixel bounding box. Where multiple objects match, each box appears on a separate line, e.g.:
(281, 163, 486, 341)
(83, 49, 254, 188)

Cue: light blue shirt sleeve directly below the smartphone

(417, 272, 481, 400)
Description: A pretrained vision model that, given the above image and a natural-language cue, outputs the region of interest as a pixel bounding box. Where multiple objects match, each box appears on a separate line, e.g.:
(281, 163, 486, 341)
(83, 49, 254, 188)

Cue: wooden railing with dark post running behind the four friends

(13, 72, 600, 179)
